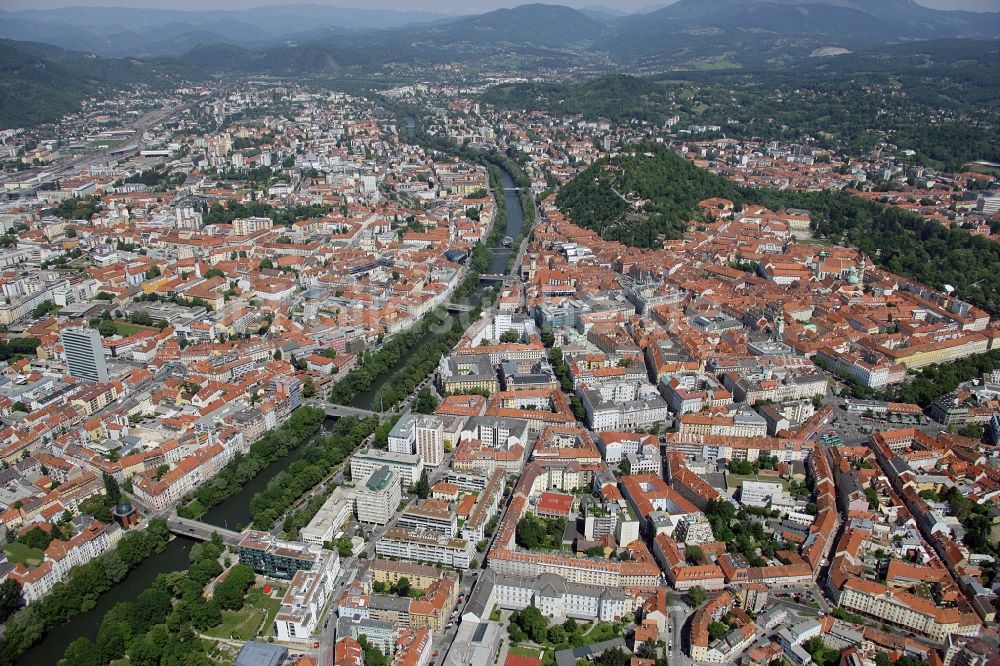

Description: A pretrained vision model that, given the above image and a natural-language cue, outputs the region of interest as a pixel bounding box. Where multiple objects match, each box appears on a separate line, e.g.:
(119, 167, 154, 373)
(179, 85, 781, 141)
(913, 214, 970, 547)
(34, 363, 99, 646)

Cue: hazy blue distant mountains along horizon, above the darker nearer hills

(0, 0, 1000, 63)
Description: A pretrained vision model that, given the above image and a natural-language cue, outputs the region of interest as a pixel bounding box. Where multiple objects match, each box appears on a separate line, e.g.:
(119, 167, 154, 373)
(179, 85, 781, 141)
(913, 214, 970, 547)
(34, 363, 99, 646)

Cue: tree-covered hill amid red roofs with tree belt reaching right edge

(557, 144, 1000, 316)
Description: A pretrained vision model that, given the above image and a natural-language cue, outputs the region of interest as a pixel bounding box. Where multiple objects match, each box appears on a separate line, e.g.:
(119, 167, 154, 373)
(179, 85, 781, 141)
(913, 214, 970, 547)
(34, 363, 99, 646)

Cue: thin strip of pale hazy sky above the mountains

(0, 0, 1000, 14)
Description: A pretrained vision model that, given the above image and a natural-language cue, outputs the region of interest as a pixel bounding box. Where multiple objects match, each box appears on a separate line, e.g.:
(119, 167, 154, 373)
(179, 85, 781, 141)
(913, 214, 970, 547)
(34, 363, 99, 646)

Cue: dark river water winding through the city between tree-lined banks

(17, 117, 524, 666)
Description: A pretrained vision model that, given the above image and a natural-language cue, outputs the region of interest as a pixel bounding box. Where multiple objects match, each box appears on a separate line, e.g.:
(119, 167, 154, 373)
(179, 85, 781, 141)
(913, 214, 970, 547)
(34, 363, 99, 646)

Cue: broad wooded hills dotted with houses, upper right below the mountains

(481, 39, 1000, 171)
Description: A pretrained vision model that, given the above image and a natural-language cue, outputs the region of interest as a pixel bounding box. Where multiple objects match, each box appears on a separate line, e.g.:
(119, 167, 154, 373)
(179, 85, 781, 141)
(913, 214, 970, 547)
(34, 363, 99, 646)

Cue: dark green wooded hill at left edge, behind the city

(0, 40, 202, 128)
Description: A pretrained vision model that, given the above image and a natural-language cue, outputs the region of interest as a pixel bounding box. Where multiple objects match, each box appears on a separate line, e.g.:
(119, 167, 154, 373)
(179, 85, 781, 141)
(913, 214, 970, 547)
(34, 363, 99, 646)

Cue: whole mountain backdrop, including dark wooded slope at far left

(0, 0, 1000, 126)
